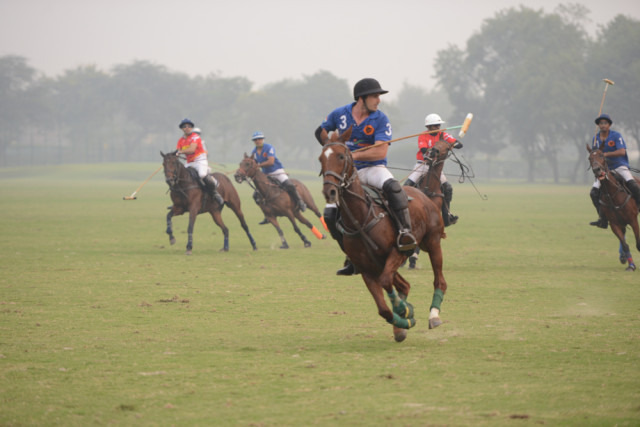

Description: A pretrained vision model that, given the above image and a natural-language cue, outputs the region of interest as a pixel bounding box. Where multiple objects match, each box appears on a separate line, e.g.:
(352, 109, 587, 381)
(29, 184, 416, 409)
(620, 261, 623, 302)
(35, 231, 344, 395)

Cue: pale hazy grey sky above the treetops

(0, 0, 640, 96)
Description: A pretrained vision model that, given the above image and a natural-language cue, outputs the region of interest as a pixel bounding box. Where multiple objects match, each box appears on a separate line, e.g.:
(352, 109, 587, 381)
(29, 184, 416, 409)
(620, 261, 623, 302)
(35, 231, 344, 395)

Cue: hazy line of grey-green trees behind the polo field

(0, 4, 640, 182)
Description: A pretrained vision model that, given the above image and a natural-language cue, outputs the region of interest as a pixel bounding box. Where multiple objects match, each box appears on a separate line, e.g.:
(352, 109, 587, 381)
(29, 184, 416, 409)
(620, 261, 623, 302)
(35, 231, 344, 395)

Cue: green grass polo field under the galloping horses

(0, 164, 640, 426)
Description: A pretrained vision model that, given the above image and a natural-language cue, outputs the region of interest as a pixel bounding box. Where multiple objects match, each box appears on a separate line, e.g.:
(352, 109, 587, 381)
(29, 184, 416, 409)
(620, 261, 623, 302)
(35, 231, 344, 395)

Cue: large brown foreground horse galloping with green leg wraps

(320, 128, 447, 341)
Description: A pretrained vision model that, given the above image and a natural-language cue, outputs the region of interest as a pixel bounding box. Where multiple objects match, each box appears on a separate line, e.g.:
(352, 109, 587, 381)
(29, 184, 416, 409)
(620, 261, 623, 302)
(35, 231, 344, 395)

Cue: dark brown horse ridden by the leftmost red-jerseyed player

(160, 151, 258, 255)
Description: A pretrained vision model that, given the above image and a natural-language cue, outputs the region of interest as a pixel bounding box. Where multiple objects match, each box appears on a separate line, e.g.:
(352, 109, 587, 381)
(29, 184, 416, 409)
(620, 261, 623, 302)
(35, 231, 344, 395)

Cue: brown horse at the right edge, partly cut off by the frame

(587, 144, 640, 271)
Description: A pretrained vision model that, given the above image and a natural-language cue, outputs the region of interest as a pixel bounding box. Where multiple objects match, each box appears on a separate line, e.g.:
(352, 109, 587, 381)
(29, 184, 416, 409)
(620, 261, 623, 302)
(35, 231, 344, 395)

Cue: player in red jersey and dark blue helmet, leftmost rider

(177, 119, 224, 206)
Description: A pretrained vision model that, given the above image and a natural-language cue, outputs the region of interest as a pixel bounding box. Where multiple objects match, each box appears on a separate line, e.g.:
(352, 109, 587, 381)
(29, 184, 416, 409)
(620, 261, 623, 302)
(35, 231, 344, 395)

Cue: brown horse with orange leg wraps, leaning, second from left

(234, 153, 326, 249)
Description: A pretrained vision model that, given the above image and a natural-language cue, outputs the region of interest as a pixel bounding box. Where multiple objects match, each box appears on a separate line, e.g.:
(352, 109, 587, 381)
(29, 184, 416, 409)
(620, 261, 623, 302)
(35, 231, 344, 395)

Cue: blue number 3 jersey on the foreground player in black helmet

(321, 102, 392, 169)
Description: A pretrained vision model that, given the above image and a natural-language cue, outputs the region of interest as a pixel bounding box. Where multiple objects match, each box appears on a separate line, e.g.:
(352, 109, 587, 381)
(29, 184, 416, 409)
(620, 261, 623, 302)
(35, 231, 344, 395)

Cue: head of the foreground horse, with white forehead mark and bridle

(319, 127, 358, 203)
